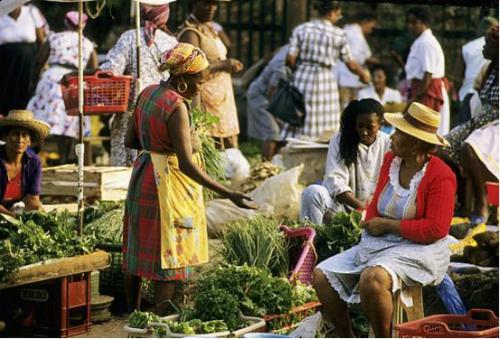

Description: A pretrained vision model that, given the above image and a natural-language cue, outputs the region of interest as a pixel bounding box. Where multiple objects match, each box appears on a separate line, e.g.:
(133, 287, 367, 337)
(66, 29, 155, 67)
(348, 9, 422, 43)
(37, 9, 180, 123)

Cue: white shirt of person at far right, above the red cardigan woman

(459, 37, 487, 101)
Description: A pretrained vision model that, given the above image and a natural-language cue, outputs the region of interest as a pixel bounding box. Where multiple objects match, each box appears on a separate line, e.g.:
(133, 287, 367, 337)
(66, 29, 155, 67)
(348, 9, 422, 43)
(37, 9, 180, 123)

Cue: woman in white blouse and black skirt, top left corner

(0, 6, 46, 116)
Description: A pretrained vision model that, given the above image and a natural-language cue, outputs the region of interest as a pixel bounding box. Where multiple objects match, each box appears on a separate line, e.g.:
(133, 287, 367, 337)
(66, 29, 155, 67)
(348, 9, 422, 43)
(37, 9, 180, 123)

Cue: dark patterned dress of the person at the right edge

(443, 65, 498, 166)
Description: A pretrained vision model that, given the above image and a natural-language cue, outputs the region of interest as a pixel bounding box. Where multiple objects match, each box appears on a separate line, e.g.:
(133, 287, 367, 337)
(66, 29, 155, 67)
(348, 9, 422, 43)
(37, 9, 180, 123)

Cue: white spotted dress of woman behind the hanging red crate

(28, 31, 94, 138)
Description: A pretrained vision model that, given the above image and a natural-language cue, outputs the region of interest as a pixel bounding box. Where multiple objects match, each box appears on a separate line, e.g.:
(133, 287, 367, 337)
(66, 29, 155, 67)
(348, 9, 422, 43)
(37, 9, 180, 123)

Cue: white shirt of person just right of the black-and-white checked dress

(338, 23, 372, 87)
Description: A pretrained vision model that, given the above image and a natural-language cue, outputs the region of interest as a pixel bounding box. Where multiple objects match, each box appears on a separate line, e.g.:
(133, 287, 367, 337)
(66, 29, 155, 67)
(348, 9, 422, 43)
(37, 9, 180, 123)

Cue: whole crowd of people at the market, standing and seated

(0, 0, 499, 337)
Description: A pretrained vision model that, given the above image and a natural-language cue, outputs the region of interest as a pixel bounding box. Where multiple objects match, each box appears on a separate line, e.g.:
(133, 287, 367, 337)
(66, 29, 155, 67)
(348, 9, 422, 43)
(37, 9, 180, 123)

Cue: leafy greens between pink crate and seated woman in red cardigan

(312, 211, 362, 262)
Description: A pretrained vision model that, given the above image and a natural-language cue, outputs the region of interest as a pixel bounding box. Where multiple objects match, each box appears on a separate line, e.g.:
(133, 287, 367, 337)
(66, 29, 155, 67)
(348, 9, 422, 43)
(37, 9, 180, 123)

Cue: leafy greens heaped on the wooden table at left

(0, 212, 95, 282)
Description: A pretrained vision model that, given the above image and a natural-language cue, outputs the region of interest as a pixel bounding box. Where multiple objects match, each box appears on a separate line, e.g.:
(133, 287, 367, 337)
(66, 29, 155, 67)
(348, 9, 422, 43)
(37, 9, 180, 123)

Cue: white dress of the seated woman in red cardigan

(317, 157, 450, 303)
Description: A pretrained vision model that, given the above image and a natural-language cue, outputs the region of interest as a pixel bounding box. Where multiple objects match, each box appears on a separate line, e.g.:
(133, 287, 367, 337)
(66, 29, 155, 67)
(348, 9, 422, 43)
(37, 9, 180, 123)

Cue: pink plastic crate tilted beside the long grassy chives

(280, 225, 318, 285)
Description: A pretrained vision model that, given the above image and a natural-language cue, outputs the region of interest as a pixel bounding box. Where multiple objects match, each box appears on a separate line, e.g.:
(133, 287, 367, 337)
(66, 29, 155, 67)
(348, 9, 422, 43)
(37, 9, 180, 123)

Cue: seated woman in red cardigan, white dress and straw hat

(313, 103, 456, 337)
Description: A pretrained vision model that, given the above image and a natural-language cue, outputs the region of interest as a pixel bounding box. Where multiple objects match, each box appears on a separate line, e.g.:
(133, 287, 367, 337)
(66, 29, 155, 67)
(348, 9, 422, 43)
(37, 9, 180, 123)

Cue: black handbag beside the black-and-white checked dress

(268, 70, 306, 127)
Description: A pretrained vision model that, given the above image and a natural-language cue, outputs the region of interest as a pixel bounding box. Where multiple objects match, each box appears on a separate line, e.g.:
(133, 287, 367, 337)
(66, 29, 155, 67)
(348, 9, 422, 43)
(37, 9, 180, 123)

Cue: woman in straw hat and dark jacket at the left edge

(0, 110, 50, 216)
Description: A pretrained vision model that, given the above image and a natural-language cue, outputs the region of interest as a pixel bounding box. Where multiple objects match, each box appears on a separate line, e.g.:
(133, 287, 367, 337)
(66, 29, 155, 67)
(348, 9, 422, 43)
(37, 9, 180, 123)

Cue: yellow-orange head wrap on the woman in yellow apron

(160, 42, 209, 75)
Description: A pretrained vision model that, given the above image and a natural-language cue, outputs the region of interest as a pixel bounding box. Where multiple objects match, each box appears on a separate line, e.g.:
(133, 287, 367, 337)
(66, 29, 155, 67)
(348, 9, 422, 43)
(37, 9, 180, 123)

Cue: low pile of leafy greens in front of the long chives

(193, 265, 316, 329)
